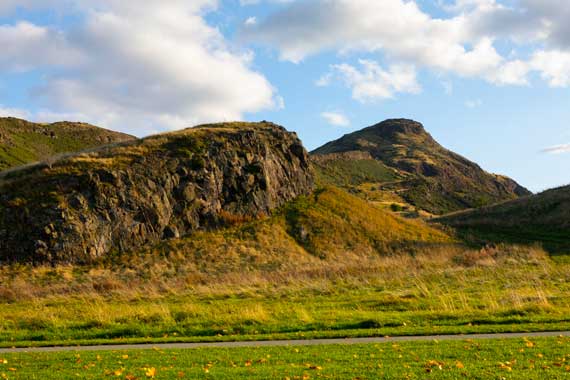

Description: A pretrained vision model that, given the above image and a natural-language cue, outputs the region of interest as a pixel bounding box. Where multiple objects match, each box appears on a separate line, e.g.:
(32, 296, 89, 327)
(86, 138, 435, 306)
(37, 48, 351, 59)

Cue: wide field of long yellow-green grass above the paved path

(0, 240, 570, 347)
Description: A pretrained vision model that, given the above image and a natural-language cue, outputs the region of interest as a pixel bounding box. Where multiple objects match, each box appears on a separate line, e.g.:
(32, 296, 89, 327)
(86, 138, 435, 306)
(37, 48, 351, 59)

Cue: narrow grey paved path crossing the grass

(0, 331, 570, 354)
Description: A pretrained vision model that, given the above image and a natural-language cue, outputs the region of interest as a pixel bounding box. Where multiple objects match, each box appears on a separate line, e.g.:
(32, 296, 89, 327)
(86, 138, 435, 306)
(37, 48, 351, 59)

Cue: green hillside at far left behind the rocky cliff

(0, 118, 136, 171)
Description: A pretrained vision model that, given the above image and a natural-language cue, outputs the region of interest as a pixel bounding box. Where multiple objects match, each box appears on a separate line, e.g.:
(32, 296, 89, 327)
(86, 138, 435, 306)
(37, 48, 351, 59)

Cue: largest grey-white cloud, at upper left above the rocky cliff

(0, 0, 279, 135)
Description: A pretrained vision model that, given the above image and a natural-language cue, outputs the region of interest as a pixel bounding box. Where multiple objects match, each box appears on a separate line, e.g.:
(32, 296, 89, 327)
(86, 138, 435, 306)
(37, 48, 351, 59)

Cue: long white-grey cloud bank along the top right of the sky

(242, 0, 570, 86)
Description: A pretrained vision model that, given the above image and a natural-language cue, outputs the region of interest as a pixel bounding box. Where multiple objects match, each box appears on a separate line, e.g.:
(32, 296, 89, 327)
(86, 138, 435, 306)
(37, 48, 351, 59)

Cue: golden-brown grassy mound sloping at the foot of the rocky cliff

(130, 187, 454, 276)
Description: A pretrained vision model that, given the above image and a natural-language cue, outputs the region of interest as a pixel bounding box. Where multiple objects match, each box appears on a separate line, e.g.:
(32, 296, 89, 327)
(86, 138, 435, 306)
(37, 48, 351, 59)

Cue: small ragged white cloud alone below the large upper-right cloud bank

(317, 60, 421, 103)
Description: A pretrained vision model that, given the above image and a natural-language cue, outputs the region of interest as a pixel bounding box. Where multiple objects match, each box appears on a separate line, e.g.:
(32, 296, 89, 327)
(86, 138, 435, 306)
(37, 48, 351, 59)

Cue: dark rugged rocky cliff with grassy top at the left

(0, 123, 313, 263)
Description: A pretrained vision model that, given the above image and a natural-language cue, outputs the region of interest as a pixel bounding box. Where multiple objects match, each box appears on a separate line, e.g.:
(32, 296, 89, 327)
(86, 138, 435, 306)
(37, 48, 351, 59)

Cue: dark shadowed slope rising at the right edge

(436, 186, 570, 253)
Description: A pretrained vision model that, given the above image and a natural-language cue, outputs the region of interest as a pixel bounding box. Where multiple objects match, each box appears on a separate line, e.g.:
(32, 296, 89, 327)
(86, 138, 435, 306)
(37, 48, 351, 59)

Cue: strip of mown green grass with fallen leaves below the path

(0, 337, 570, 380)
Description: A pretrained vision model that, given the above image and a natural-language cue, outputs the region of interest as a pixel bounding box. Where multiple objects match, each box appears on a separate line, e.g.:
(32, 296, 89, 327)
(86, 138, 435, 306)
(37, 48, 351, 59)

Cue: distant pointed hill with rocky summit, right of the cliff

(311, 119, 530, 214)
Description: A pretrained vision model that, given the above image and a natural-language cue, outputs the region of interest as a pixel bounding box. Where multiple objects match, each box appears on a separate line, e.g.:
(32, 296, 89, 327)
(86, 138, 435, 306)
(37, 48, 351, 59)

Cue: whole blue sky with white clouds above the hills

(0, 0, 570, 191)
